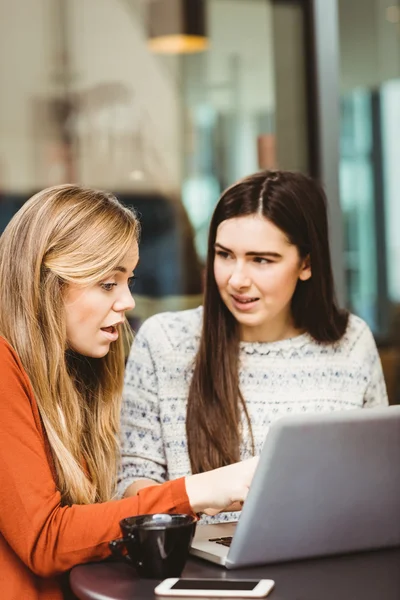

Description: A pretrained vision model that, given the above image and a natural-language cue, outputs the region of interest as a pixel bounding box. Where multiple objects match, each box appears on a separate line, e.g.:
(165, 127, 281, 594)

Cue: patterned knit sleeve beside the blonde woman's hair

(118, 317, 167, 496)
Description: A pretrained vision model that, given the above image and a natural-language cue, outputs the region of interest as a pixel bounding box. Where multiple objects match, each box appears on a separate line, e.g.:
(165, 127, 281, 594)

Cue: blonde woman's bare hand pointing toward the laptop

(186, 456, 258, 514)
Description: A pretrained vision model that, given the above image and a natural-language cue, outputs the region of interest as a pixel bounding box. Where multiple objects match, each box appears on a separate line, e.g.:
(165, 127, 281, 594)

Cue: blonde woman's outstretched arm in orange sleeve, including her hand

(0, 338, 255, 577)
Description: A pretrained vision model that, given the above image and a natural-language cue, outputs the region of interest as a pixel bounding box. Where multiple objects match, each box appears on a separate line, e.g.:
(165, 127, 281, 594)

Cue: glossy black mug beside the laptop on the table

(109, 513, 197, 579)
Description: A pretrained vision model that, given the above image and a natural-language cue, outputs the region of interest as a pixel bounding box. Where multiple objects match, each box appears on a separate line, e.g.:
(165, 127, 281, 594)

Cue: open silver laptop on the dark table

(191, 406, 400, 569)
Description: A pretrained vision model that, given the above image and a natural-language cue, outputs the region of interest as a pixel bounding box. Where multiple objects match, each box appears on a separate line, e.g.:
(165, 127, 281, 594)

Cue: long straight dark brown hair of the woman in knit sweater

(186, 171, 348, 473)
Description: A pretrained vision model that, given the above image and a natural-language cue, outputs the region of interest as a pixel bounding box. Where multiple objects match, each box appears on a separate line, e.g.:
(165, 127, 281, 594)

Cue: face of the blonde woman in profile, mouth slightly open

(64, 242, 139, 358)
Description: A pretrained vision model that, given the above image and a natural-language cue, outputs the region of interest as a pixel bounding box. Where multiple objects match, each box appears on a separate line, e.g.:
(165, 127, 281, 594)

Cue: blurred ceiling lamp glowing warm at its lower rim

(149, 0, 208, 54)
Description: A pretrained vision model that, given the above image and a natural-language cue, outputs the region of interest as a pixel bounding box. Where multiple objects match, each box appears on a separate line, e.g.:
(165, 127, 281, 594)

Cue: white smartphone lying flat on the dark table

(154, 577, 275, 598)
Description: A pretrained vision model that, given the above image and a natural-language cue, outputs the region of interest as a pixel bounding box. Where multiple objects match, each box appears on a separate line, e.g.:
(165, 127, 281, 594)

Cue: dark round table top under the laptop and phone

(70, 548, 400, 600)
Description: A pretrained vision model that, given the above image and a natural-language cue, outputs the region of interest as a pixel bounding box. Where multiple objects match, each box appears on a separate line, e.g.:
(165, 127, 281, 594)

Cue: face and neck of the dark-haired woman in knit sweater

(214, 215, 311, 342)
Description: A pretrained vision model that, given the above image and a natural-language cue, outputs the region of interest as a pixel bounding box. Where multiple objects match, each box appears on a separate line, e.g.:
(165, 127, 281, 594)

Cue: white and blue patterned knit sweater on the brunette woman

(118, 307, 388, 519)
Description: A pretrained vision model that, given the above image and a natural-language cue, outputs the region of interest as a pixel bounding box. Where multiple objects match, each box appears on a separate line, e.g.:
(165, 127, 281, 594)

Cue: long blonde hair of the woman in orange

(0, 185, 139, 504)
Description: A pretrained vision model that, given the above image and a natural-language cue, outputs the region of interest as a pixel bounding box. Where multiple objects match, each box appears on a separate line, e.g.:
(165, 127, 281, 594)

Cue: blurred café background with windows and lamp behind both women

(0, 0, 400, 403)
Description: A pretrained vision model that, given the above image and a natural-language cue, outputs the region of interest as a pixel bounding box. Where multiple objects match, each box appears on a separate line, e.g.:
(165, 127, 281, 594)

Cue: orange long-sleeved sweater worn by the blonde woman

(0, 337, 191, 600)
